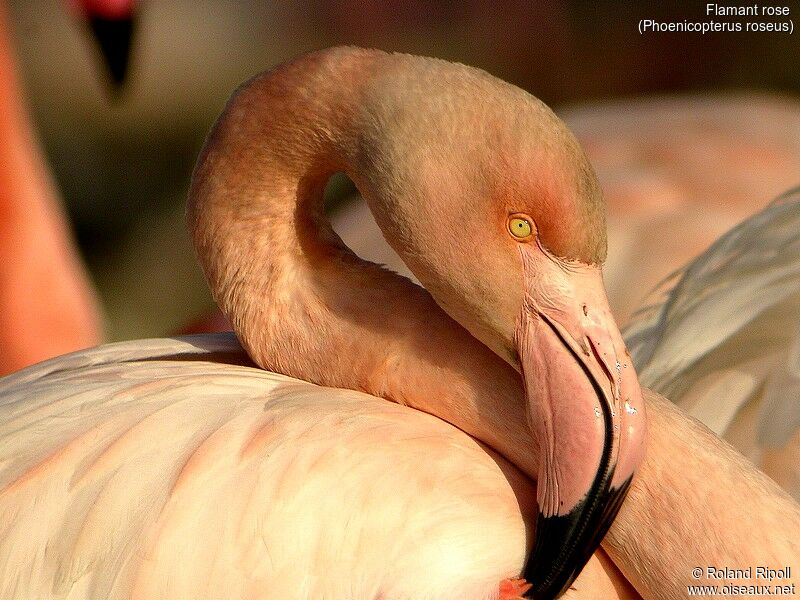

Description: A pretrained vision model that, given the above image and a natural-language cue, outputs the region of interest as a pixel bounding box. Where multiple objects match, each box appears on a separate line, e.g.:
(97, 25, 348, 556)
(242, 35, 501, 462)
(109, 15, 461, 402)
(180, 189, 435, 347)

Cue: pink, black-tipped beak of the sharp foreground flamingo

(516, 253, 645, 598)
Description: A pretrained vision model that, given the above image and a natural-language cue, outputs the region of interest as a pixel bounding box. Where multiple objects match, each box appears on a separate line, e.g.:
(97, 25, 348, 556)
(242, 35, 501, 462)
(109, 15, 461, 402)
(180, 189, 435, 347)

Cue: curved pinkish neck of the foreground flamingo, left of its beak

(188, 48, 538, 475)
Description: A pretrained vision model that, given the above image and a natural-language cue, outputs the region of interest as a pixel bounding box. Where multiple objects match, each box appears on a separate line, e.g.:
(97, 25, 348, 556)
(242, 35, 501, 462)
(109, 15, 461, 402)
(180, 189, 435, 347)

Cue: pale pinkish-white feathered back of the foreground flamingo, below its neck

(0, 334, 532, 600)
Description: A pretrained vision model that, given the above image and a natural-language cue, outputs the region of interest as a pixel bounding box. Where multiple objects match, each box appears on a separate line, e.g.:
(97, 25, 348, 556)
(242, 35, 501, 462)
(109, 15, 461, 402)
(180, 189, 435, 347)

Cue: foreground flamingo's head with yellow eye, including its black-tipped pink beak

(353, 57, 645, 597)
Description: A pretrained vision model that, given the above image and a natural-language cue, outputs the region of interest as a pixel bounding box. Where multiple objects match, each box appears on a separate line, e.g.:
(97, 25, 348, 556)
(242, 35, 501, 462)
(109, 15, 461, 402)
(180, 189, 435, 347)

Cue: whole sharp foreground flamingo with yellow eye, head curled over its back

(0, 49, 798, 598)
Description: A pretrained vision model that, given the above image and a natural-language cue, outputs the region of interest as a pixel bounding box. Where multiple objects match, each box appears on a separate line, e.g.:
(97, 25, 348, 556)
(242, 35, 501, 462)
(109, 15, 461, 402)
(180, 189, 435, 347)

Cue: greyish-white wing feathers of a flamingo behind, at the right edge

(625, 189, 800, 499)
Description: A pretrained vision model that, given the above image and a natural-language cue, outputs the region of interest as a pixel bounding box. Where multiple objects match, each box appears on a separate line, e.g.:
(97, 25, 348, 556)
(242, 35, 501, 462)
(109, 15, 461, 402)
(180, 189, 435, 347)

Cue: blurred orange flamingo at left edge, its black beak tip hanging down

(0, 0, 135, 374)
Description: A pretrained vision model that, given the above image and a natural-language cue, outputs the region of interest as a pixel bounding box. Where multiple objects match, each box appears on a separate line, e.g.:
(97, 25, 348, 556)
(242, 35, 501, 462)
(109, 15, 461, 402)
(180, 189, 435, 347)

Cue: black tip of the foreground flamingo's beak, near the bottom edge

(523, 479, 631, 600)
